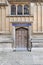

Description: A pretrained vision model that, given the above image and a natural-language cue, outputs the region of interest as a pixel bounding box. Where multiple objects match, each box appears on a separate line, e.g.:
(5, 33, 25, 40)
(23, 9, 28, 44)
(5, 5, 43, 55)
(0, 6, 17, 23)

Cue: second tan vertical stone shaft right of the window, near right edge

(38, 4, 42, 32)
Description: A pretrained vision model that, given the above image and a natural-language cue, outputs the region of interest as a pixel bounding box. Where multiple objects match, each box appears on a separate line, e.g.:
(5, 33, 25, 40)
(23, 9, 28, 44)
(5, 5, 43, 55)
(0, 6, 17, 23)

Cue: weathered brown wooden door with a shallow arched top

(15, 27, 28, 50)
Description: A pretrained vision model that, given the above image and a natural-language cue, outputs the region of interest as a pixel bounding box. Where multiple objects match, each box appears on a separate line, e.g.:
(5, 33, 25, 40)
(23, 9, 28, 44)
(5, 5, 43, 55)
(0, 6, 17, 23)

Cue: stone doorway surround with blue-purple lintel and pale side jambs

(12, 22, 32, 51)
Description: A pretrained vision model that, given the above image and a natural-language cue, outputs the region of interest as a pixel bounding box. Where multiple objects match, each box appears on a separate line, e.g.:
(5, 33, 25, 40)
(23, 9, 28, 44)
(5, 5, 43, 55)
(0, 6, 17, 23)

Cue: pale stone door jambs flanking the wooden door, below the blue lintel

(12, 23, 32, 50)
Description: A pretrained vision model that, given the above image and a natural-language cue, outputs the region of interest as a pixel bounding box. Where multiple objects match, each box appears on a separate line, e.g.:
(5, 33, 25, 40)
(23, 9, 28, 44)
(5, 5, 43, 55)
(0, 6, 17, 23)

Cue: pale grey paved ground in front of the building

(0, 51, 43, 65)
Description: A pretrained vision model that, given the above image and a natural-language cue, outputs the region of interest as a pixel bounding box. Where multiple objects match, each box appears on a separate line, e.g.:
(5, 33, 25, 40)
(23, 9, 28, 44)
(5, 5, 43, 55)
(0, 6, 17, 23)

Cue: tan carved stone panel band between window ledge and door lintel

(7, 15, 33, 23)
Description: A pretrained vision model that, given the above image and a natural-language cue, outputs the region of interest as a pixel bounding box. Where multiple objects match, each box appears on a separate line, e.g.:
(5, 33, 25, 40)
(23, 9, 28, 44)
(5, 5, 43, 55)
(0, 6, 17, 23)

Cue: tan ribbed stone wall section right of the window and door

(31, 3, 43, 33)
